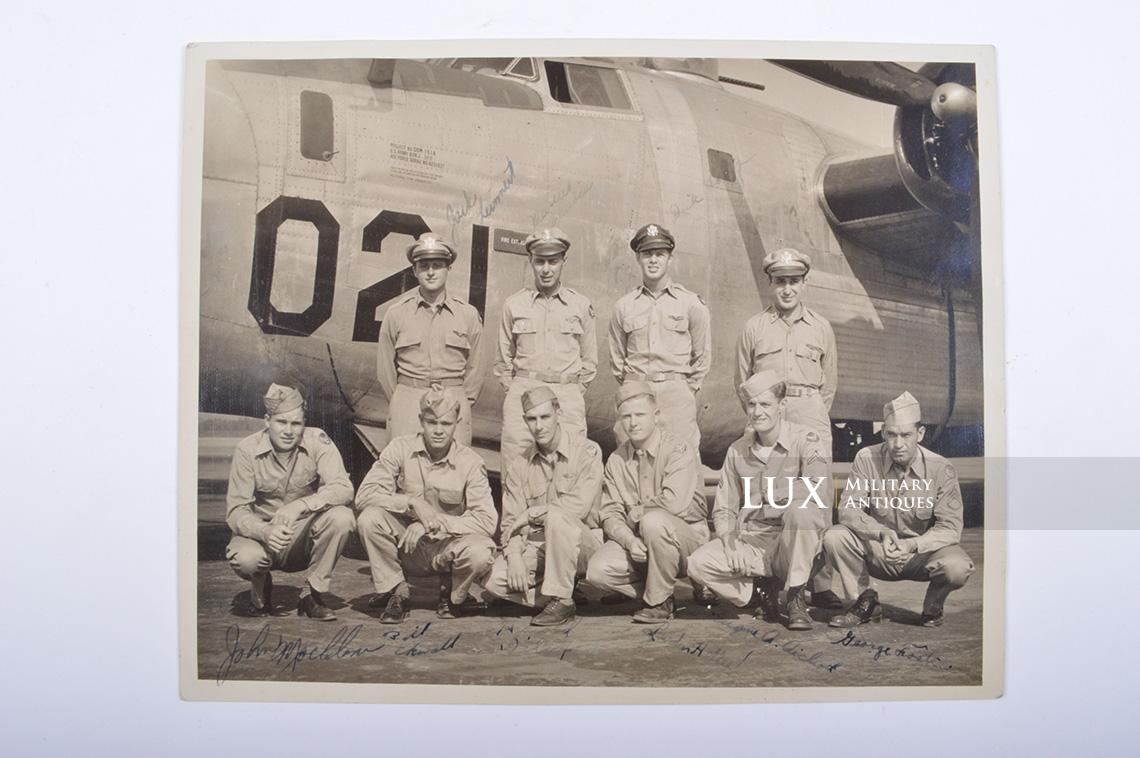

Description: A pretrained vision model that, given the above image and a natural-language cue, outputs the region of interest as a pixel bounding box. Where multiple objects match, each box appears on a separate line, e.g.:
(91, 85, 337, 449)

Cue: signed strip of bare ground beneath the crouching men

(196, 495, 984, 687)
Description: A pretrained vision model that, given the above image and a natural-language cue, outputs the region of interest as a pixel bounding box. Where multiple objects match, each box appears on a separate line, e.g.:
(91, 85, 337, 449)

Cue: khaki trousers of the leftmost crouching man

(226, 505, 355, 593)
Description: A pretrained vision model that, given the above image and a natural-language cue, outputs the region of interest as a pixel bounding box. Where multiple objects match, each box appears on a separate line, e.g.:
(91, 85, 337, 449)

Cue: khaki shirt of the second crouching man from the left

(356, 434, 498, 537)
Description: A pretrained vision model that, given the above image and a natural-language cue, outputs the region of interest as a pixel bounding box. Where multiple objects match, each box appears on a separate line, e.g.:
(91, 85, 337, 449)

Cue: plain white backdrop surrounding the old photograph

(0, 0, 1140, 757)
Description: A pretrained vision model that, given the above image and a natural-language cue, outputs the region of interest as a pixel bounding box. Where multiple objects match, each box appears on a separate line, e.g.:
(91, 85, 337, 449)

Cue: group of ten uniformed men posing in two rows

(227, 223, 974, 630)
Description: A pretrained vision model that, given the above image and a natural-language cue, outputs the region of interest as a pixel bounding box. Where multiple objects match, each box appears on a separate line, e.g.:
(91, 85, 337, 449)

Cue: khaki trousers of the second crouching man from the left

(357, 506, 495, 603)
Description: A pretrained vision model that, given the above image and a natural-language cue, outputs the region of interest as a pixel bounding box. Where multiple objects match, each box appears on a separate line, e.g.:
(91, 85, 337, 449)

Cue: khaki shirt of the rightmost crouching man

(839, 442, 962, 553)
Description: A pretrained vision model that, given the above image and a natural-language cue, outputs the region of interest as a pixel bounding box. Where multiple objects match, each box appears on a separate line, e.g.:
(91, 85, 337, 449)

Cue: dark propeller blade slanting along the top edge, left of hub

(768, 60, 935, 107)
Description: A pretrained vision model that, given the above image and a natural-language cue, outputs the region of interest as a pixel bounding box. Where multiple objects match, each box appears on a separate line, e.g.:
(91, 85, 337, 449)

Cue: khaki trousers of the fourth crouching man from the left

(586, 508, 709, 605)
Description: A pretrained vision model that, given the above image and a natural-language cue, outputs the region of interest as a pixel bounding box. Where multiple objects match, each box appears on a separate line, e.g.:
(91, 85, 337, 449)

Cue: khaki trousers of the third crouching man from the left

(483, 508, 602, 608)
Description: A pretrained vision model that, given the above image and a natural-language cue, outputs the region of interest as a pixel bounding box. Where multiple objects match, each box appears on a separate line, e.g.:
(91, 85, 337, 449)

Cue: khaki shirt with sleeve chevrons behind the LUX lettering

(713, 422, 834, 537)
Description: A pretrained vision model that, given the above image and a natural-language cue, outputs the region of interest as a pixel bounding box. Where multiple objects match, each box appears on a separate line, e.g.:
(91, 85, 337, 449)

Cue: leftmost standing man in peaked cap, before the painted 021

(376, 233, 485, 445)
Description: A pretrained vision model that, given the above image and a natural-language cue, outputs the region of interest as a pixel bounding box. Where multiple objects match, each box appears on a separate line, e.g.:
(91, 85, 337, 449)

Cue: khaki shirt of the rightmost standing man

(736, 305, 839, 410)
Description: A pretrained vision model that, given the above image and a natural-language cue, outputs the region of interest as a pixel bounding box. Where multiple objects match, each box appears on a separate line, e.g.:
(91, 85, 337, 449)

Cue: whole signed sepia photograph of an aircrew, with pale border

(179, 42, 1004, 702)
